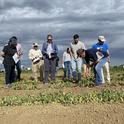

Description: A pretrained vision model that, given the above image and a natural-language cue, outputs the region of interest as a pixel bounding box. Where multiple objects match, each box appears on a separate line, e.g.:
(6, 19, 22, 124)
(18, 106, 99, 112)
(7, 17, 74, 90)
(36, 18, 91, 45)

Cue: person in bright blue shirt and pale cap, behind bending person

(92, 36, 110, 83)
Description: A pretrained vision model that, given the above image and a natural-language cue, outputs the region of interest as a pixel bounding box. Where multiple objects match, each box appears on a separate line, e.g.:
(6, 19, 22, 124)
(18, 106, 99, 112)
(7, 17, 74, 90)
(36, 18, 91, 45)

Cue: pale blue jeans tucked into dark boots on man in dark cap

(71, 58, 83, 80)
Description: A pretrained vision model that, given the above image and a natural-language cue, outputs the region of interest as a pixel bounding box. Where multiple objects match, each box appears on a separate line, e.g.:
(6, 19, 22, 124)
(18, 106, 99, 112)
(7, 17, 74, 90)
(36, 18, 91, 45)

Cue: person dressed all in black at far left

(2, 38, 17, 86)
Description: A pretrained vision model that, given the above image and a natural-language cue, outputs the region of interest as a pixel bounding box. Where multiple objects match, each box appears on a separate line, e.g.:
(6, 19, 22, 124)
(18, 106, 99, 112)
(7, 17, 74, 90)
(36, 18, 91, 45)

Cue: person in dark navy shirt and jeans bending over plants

(77, 48, 109, 85)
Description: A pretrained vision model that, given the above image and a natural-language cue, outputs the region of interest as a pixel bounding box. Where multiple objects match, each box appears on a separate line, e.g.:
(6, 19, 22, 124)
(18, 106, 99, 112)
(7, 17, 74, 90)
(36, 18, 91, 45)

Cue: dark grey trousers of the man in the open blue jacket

(44, 59, 56, 83)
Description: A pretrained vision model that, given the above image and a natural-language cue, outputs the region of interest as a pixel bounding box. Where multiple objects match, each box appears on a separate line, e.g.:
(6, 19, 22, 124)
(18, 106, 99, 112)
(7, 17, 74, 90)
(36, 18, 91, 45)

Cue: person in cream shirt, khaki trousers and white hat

(29, 43, 44, 82)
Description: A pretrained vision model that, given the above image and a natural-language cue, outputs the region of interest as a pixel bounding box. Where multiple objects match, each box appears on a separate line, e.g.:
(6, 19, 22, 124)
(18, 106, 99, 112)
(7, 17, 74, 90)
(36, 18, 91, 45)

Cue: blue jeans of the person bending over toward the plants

(95, 58, 107, 85)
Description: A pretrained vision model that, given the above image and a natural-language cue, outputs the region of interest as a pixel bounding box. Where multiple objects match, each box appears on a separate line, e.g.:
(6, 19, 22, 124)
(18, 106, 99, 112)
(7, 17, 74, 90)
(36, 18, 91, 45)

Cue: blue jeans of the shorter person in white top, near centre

(64, 61, 71, 78)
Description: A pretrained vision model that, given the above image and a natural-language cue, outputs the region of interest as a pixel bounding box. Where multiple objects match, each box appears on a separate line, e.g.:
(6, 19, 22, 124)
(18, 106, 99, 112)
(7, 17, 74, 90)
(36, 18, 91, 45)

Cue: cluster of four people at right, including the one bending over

(63, 34, 110, 85)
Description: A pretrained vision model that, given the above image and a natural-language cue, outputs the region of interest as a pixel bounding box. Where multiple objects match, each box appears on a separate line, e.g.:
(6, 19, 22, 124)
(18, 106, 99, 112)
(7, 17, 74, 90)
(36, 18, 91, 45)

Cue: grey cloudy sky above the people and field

(0, 0, 124, 65)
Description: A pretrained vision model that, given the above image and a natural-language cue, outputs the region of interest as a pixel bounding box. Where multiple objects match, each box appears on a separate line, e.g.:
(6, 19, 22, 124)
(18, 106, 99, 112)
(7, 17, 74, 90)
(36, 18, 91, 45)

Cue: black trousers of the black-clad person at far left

(4, 64, 15, 84)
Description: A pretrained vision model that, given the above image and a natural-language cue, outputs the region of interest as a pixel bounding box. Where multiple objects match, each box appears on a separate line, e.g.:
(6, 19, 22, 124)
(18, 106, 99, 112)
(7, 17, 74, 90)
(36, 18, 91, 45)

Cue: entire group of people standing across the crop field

(1, 34, 110, 85)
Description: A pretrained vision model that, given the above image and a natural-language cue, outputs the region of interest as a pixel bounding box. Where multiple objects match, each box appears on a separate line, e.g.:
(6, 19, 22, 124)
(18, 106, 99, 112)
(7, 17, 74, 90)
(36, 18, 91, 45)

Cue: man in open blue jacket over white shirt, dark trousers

(42, 34, 58, 84)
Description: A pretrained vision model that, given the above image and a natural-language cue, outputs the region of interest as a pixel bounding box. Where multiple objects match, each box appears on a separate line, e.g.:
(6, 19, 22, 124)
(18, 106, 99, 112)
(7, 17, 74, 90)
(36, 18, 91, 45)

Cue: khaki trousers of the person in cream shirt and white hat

(32, 60, 44, 82)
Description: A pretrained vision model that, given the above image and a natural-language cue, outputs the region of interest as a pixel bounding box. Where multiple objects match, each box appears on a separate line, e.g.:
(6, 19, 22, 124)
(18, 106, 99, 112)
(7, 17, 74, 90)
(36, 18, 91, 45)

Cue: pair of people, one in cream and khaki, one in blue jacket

(29, 34, 58, 84)
